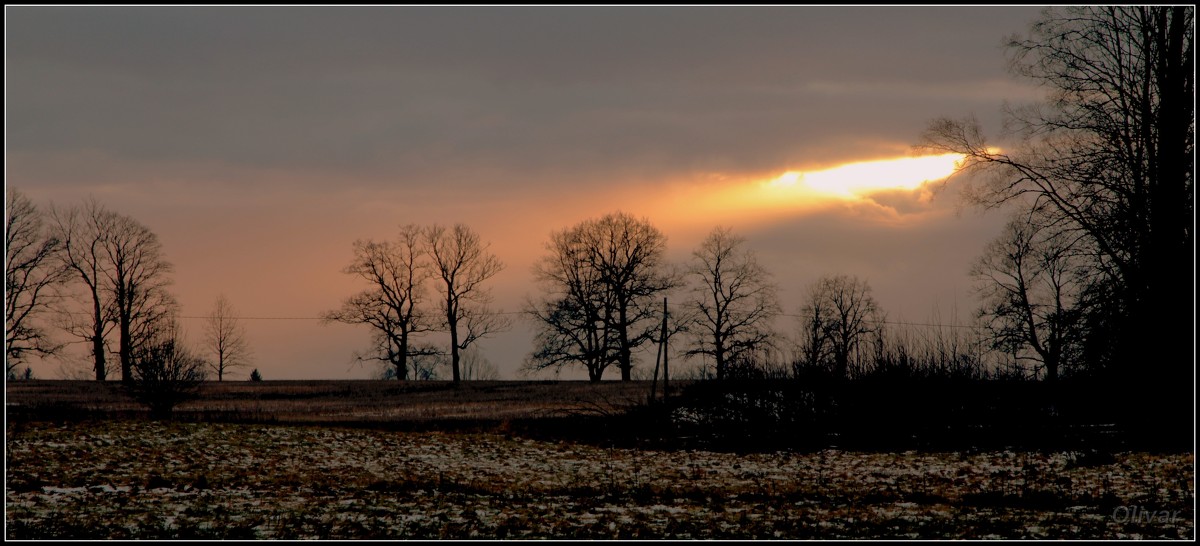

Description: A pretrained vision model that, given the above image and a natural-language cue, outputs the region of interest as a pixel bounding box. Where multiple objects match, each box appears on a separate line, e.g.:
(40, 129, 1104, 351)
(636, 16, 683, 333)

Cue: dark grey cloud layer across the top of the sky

(6, 7, 1033, 189)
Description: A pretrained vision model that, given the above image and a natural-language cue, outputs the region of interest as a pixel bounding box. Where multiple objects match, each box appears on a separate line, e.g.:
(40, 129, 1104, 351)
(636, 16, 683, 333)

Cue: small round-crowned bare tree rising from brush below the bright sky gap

(800, 275, 883, 378)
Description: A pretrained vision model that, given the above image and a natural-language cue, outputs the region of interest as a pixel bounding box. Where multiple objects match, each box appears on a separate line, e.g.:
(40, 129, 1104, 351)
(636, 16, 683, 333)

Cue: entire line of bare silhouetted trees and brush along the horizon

(6, 6, 1195, 427)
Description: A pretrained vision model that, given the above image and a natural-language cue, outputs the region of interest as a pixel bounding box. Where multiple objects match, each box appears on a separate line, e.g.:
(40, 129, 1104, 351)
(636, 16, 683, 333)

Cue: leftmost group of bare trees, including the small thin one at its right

(5, 188, 251, 384)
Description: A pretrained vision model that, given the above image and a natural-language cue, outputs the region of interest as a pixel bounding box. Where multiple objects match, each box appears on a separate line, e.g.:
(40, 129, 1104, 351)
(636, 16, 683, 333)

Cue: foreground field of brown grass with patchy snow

(5, 420, 1195, 539)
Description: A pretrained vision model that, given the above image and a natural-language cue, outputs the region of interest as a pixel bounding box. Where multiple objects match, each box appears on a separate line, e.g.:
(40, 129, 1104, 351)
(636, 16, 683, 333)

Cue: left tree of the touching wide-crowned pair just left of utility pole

(526, 222, 618, 382)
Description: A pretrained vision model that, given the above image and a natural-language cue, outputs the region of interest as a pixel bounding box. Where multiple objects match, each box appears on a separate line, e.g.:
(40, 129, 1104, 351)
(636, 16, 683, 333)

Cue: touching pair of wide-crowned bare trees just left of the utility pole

(527, 212, 677, 380)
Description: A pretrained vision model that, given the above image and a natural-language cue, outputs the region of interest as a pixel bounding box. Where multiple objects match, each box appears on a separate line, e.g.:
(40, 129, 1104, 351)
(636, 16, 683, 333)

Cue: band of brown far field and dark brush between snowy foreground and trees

(6, 377, 1194, 451)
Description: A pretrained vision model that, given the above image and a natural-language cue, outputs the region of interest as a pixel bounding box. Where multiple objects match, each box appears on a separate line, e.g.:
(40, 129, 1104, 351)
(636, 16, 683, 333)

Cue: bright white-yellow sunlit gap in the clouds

(767, 154, 962, 198)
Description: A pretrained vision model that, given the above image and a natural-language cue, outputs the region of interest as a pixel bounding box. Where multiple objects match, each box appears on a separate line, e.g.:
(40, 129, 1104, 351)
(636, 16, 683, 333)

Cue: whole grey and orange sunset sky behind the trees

(5, 6, 1040, 379)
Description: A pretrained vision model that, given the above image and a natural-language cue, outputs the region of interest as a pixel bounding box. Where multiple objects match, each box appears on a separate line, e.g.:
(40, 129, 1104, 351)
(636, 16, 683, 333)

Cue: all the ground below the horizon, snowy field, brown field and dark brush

(6, 380, 1195, 539)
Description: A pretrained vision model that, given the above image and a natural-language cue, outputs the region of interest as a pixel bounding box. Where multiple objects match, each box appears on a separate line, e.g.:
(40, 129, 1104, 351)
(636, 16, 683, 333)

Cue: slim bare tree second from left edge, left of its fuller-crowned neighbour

(50, 198, 113, 380)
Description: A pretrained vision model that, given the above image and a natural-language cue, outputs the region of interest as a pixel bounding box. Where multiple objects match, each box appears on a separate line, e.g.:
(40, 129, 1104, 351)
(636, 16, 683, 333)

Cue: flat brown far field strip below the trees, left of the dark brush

(5, 380, 674, 422)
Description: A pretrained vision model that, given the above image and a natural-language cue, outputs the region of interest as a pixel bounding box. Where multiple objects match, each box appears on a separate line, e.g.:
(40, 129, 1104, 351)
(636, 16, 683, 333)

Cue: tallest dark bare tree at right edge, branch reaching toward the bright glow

(923, 6, 1195, 384)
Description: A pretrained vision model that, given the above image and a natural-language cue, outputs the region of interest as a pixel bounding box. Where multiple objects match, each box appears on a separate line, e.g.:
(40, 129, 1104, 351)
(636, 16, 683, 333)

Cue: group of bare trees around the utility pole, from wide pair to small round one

(524, 212, 897, 380)
